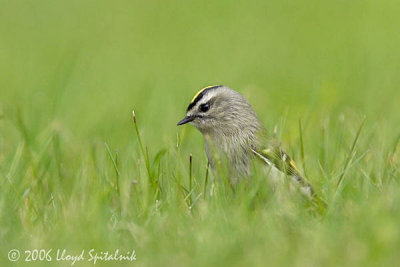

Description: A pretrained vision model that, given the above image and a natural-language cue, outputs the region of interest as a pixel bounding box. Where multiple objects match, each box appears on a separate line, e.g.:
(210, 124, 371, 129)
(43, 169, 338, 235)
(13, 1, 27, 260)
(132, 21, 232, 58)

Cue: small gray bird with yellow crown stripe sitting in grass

(178, 85, 321, 206)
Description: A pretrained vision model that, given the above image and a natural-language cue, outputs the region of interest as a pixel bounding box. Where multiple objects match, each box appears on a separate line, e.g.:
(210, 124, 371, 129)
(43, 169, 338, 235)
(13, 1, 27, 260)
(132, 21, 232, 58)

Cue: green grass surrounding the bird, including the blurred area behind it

(0, 0, 400, 266)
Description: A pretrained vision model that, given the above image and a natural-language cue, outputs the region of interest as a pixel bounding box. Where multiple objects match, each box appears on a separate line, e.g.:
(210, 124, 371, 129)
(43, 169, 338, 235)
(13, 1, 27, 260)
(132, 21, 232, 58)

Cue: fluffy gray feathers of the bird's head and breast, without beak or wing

(186, 86, 263, 180)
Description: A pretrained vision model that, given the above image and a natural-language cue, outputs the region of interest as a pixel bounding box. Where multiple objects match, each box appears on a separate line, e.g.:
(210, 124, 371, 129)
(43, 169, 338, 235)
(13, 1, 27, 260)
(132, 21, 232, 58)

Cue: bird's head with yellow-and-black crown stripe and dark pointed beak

(178, 85, 260, 135)
